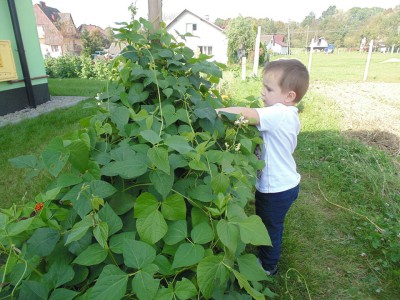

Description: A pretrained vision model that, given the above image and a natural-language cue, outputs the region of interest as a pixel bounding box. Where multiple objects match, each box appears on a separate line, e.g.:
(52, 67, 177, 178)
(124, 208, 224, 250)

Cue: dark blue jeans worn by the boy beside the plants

(255, 185, 299, 271)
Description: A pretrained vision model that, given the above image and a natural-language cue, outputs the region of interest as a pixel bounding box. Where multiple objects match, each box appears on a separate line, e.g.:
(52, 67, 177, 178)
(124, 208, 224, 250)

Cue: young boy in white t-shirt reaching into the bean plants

(216, 59, 309, 275)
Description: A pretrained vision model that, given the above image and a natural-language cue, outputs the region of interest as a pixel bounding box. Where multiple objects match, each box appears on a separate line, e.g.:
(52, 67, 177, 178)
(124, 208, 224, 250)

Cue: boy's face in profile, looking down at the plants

(261, 72, 293, 106)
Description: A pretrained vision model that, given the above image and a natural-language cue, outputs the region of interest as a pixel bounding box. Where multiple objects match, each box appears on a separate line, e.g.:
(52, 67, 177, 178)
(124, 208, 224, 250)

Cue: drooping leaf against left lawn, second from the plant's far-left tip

(42, 137, 70, 177)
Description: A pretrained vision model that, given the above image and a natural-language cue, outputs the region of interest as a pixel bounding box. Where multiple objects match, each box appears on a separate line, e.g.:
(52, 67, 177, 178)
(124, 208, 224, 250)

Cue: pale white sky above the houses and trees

(32, 0, 400, 29)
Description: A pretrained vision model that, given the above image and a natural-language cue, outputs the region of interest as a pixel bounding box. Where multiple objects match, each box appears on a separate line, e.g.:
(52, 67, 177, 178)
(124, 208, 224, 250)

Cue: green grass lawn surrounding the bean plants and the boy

(0, 53, 400, 300)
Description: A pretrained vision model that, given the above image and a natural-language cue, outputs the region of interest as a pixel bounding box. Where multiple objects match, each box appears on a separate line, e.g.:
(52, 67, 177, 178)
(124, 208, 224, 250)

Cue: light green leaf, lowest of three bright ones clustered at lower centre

(136, 210, 168, 244)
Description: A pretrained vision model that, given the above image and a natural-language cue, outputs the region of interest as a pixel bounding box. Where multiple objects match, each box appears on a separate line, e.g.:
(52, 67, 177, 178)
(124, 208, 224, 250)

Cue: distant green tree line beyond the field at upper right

(214, 5, 400, 60)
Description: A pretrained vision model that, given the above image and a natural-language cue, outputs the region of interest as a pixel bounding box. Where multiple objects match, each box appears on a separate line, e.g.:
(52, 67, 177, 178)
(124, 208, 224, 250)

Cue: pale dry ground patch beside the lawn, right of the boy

(312, 82, 400, 157)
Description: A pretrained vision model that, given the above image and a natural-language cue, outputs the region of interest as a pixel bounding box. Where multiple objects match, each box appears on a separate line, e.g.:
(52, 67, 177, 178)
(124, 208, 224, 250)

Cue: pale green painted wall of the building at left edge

(0, 0, 47, 91)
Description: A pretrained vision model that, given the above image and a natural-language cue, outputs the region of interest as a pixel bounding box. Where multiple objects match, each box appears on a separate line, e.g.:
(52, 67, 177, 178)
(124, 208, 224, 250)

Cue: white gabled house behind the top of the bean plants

(167, 9, 228, 64)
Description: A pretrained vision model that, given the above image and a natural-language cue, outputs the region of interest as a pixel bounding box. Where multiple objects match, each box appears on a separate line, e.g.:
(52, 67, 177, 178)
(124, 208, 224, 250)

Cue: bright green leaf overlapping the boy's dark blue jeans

(238, 215, 272, 246)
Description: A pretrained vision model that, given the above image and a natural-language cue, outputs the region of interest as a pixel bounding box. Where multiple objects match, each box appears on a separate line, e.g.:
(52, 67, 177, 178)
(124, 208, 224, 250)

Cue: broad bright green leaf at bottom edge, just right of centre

(197, 254, 229, 299)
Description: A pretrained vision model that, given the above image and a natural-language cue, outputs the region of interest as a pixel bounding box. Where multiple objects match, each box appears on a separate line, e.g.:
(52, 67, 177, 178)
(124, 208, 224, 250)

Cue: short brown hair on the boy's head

(263, 59, 310, 103)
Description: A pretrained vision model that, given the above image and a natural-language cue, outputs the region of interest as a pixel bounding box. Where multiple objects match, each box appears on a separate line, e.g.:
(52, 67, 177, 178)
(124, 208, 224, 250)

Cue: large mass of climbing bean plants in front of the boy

(0, 19, 270, 299)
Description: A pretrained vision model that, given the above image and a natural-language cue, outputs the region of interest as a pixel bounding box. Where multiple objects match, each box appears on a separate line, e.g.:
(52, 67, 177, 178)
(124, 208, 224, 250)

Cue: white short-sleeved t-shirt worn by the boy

(256, 103, 300, 193)
